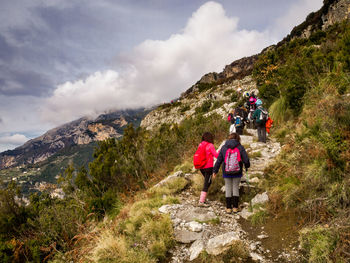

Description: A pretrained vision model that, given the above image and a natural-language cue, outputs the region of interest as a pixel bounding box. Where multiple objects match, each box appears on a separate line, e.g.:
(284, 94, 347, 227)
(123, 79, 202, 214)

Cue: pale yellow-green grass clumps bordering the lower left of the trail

(86, 177, 188, 263)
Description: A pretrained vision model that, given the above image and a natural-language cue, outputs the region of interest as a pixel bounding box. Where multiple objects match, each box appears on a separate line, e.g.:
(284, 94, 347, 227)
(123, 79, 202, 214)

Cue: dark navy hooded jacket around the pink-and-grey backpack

(213, 140, 250, 178)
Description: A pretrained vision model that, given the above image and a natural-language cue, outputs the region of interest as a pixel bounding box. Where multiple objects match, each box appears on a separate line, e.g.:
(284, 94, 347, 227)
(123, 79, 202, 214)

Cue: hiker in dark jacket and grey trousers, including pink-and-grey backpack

(213, 133, 250, 213)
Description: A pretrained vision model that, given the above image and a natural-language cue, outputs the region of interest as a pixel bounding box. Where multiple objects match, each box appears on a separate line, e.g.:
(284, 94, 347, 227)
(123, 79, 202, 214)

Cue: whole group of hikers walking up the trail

(193, 93, 273, 213)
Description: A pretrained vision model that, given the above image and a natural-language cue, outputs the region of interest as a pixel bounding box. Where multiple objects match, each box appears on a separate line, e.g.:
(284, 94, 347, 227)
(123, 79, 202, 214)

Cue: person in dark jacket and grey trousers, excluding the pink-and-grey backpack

(213, 133, 250, 213)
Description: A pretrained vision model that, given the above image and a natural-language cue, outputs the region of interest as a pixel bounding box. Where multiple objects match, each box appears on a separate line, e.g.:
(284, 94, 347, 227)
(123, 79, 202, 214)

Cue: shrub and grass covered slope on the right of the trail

(254, 22, 350, 262)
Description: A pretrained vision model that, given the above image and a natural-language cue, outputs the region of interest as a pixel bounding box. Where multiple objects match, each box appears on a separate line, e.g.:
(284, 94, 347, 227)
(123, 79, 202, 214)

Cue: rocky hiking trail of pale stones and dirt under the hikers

(158, 129, 297, 263)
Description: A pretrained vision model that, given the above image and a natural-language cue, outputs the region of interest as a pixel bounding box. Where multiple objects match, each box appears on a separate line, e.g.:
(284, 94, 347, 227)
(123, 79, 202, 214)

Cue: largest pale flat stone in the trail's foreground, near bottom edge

(206, 232, 240, 256)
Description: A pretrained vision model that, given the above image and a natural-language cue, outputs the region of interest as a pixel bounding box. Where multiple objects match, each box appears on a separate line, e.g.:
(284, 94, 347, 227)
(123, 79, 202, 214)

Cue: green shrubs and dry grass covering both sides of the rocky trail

(0, 5, 350, 263)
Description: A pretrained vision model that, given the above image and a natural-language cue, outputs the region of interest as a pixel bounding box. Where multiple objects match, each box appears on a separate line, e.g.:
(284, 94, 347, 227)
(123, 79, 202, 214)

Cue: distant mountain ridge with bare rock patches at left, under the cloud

(0, 109, 146, 169)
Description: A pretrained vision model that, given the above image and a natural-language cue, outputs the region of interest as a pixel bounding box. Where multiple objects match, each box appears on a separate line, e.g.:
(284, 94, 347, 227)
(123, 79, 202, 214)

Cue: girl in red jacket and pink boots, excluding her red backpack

(199, 132, 219, 205)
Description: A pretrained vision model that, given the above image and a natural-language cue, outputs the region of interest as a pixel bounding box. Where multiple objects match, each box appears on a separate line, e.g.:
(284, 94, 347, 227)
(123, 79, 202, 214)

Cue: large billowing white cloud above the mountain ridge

(42, 2, 276, 124)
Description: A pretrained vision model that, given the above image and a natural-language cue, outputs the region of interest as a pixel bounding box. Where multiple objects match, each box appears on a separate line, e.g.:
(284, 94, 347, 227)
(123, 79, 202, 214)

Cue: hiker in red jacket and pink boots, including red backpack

(193, 132, 219, 206)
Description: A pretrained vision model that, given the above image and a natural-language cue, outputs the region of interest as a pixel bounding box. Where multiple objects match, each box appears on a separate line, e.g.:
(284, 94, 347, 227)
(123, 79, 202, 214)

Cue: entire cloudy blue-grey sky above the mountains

(0, 0, 322, 152)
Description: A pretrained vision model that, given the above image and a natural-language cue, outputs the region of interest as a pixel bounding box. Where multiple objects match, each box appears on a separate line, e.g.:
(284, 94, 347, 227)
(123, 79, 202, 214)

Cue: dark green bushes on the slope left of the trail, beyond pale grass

(0, 114, 228, 262)
